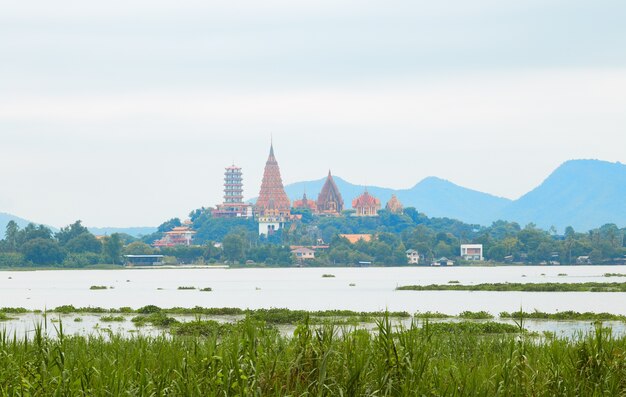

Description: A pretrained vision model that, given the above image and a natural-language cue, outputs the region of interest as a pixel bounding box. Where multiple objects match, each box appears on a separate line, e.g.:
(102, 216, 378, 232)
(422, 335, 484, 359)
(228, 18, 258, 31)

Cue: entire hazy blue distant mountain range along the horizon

(0, 160, 626, 236)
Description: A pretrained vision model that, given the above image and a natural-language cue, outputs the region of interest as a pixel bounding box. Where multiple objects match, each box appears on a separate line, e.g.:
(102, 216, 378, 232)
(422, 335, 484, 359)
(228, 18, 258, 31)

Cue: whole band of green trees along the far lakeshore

(0, 208, 626, 267)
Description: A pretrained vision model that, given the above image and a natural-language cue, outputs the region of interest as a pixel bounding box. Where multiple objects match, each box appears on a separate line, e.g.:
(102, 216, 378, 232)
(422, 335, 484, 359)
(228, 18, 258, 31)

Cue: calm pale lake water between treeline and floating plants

(0, 266, 626, 315)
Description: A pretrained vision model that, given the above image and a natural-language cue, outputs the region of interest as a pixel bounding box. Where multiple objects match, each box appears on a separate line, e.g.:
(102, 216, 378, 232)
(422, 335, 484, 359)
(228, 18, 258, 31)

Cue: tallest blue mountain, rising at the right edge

(498, 160, 626, 232)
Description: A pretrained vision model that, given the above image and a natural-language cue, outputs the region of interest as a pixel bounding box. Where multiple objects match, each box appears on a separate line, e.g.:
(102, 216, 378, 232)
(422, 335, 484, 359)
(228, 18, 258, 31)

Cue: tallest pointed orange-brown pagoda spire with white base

(254, 144, 291, 236)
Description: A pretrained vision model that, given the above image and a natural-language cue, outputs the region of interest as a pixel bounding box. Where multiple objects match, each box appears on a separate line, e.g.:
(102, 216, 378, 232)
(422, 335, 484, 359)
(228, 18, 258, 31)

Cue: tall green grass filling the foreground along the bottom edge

(0, 316, 626, 396)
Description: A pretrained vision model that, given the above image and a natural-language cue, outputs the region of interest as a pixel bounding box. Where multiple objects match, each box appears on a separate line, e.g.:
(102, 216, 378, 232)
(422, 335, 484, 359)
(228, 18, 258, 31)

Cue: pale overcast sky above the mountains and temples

(0, 0, 626, 227)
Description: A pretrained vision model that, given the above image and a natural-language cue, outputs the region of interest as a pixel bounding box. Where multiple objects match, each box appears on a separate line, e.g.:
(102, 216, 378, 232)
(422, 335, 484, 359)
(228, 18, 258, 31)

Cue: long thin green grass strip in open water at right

(396, 282, 626, 292)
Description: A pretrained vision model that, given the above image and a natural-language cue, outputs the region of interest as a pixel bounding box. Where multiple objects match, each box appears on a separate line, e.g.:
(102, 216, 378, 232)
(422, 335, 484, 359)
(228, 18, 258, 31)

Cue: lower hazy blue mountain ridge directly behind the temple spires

(285, 177, 511, 225)
